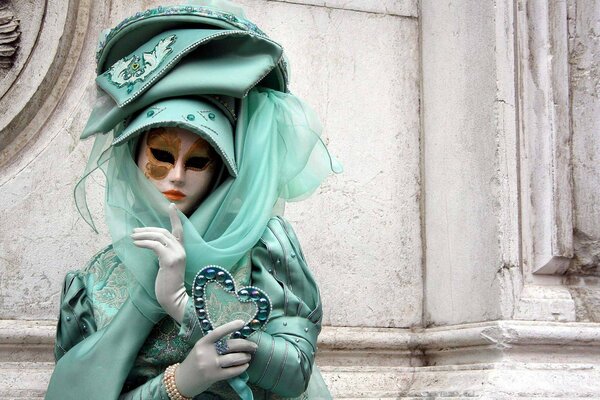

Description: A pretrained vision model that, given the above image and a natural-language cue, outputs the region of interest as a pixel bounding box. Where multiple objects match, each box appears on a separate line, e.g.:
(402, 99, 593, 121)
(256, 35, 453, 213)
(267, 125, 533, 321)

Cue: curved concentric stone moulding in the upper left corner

(0, 0, 83, 166)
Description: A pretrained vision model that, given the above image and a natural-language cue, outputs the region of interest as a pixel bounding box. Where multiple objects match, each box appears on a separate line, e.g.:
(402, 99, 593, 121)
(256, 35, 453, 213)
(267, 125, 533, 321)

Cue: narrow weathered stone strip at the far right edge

(568, 0, 600, 275)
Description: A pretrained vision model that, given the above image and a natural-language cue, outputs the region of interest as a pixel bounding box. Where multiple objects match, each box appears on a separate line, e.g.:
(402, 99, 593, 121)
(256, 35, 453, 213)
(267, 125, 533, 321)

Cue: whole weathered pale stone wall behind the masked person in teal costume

(0, 0, 600, 399)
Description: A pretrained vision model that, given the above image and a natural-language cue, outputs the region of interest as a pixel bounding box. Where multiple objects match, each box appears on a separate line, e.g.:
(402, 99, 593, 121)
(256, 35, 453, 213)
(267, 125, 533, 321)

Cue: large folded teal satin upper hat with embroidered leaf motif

(81, 5, 288, 139)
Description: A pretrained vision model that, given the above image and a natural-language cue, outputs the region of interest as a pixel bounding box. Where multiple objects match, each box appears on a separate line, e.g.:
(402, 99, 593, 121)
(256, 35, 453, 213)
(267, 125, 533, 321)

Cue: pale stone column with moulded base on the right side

(406, 0, 600, 399)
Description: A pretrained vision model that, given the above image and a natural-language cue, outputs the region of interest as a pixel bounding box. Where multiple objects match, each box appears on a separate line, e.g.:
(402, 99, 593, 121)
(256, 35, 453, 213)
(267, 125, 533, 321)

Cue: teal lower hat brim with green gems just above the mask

(112, 97, 237, 177)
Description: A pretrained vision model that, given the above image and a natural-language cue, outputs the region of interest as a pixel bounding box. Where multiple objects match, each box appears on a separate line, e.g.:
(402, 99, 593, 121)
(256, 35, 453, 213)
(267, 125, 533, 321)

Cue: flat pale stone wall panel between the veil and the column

(248, 4, 422, 327)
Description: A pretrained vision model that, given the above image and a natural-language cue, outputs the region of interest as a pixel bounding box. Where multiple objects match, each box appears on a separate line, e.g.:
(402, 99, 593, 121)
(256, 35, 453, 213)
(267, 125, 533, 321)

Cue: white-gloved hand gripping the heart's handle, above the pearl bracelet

(175, 320, 257, 397)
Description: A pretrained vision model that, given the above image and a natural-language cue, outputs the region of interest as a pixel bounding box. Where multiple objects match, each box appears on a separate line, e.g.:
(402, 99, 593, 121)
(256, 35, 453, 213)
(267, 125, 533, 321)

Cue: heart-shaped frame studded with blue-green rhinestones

(192, 265, 273, 339)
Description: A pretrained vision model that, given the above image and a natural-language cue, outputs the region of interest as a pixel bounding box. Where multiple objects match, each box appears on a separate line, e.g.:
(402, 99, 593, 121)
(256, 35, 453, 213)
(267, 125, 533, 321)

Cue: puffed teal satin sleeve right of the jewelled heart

(248, 217, 322, 397)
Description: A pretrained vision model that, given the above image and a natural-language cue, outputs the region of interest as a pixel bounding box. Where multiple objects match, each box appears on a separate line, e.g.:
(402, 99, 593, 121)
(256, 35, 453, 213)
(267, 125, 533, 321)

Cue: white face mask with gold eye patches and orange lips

(137, 127, 221, 215)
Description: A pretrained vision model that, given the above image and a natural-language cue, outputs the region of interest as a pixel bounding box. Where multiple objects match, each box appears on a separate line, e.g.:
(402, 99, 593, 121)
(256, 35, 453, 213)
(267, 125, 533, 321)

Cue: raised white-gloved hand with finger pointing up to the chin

(131, 203, 189, 324)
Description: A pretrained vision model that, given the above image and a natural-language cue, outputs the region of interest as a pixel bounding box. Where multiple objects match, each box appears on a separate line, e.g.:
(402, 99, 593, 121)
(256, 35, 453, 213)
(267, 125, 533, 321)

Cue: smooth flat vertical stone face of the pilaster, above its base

(421, 1, 521, 325)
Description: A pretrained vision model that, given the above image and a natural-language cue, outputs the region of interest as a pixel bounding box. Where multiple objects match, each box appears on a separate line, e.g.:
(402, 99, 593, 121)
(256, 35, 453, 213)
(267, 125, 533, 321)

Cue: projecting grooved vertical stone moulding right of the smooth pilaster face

(517, 0, 573, 275)
